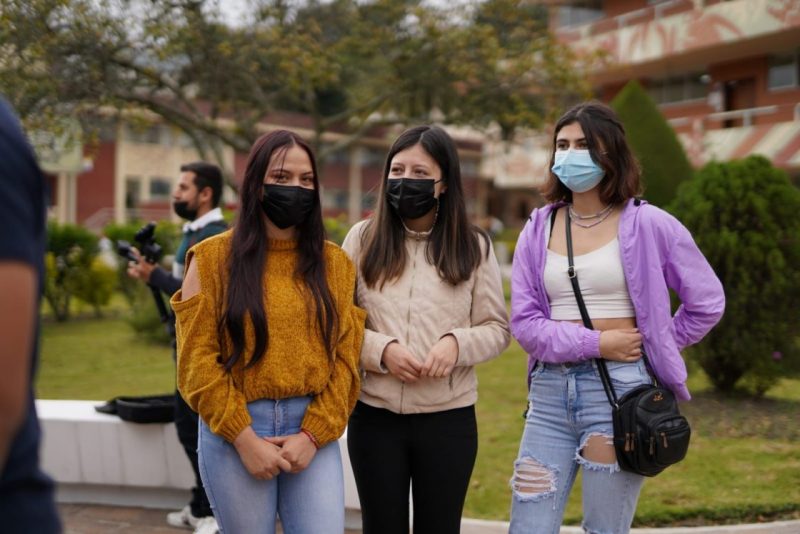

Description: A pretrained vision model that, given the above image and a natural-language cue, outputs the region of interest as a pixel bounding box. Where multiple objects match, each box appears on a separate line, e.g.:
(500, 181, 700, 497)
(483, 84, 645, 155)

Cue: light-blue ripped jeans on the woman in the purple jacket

(509, 360, 651, 534)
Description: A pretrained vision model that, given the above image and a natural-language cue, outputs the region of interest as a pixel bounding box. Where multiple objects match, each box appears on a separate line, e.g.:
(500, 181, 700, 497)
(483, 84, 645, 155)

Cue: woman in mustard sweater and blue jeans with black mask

(172, 131, 365, 534)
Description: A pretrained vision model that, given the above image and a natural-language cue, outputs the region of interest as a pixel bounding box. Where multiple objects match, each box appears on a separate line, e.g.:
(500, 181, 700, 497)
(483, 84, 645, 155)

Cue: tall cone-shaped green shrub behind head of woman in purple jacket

(611, 80, 694, 207)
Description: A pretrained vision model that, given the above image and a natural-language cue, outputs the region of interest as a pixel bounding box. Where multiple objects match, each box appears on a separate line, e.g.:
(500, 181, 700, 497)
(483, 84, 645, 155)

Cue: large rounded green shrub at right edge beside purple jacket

(670, 156, 800, 396)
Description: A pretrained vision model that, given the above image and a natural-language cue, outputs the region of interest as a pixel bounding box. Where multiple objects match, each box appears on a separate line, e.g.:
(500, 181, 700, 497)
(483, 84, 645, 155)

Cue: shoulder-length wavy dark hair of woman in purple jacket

(542, 101, 643, 204)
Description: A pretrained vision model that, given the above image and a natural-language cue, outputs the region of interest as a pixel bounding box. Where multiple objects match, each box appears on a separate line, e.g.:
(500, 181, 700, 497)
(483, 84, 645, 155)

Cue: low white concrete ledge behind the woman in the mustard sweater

(36, 400, 361, 515)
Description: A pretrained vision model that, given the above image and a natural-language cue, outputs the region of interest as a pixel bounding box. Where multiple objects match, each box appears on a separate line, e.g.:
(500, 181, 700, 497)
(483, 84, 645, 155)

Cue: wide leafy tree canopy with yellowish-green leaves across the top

(0, 0, 587, 170)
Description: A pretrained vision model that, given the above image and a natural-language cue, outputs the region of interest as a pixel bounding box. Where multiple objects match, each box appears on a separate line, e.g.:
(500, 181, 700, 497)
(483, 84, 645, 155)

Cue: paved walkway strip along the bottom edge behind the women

(59, 504, 800, 534)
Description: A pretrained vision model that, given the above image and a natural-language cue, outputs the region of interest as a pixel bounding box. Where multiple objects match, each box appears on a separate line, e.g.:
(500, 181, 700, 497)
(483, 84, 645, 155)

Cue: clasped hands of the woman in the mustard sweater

(233, 427, 317, 480)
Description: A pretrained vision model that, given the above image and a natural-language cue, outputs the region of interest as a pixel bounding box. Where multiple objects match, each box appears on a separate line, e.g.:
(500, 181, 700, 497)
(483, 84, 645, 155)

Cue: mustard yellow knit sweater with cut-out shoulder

(171, 230, 366, 445)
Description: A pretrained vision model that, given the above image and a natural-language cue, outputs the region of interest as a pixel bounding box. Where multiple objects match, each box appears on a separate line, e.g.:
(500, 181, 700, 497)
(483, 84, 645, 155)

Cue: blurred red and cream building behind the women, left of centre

(45, 113, 487, 232)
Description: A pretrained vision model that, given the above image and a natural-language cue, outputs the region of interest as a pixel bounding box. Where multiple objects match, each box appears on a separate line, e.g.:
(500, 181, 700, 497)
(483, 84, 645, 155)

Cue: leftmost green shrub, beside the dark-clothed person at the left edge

(44, 222, 97, 321)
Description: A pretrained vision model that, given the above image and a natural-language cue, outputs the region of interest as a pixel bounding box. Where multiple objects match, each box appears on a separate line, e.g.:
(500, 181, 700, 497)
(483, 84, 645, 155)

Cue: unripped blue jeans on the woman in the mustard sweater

(198, 397, 344, 534)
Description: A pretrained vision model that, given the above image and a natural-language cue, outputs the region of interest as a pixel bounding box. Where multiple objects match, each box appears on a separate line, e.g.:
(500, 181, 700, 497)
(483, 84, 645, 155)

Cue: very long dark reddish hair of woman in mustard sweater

(219, 130, 338, 370)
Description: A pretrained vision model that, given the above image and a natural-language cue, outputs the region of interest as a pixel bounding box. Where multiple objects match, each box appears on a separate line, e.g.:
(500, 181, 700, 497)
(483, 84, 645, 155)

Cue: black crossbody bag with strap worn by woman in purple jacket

(565, 210, 691, 477)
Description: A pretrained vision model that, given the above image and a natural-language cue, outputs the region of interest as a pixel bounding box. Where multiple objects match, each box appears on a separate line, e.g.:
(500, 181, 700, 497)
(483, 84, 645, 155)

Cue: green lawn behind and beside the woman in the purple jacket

(465, 343, 800, 526)
